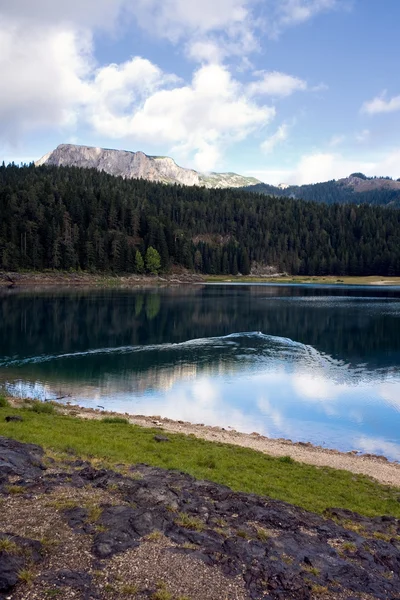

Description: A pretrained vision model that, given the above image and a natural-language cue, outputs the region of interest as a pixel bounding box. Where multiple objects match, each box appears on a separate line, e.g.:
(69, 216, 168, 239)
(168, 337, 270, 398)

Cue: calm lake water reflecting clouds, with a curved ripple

(0, 285, 400, 460)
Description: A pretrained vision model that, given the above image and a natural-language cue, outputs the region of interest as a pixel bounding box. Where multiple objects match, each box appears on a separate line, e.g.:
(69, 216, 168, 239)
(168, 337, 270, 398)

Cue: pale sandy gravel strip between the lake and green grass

(8, 398, 400, 487)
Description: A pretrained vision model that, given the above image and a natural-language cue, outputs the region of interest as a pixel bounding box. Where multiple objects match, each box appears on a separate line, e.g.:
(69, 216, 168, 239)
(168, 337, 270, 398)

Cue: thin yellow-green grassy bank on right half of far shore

(205, 275, 400, 285)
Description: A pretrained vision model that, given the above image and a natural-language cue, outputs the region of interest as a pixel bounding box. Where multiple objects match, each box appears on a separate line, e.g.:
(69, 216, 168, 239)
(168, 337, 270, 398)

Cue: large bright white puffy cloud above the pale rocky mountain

(89, 59, 275, 170)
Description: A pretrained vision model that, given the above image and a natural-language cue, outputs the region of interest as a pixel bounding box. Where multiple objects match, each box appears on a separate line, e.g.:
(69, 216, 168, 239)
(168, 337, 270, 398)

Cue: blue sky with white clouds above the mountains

(0, 0, 400, 185)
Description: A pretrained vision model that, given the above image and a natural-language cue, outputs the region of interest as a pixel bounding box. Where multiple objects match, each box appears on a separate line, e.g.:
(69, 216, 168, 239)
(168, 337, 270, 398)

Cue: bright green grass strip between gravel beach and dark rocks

(0, 408, 400, 518)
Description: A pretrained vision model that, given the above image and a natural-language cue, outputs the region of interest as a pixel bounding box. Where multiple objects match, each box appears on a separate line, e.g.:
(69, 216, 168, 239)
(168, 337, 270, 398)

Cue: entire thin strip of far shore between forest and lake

(0, 271, 400, 289)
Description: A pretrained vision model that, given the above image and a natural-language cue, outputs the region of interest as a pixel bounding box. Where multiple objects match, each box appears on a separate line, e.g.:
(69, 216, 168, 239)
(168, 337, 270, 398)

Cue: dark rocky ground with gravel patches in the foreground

(0, 436, 400, 600)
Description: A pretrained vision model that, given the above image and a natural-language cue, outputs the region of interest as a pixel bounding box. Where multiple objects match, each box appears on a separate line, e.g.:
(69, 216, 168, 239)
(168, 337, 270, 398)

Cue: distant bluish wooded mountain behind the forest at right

(246, 173, 400, 208)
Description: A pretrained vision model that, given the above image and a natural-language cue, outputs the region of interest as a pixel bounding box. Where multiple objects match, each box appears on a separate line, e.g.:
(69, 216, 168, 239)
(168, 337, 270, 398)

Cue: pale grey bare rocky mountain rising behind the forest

(35, 144, 261, 188)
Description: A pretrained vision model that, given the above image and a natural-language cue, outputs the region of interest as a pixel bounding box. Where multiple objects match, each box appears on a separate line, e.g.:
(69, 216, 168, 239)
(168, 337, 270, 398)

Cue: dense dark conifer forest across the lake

(0, 165, 400, 275)
